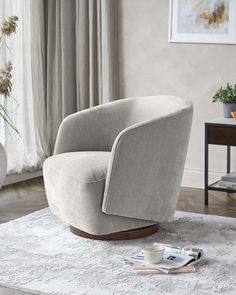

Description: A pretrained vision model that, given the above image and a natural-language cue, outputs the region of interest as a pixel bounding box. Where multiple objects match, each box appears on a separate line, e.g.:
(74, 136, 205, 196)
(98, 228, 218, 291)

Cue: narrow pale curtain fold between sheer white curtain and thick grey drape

(30, 0, 50, 166)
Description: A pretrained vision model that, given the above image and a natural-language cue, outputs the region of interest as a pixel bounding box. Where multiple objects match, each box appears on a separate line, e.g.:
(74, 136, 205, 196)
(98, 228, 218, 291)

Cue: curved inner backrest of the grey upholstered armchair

(54, 95, 191, 154)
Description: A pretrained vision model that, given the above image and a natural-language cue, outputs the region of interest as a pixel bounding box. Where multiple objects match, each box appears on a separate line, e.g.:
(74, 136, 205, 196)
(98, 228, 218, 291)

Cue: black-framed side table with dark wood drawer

(204, 118, 236, 205)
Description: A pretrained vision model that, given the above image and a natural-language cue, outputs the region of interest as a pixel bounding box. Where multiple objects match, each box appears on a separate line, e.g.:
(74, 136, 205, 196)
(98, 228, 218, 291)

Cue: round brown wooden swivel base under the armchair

(70, 224, 158, 241)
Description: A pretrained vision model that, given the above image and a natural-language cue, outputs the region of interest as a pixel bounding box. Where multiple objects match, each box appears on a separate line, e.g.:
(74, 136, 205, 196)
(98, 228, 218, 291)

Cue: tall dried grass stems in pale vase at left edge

(0, 16, 19, 188)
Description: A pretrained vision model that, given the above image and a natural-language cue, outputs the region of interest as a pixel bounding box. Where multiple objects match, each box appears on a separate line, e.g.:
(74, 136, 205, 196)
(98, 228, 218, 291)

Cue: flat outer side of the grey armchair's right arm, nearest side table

(102, 103, 192, 221)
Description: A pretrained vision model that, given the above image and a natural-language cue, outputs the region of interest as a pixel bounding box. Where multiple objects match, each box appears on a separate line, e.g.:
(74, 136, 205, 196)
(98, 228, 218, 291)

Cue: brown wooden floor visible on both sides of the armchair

(0, 177, 236, 223)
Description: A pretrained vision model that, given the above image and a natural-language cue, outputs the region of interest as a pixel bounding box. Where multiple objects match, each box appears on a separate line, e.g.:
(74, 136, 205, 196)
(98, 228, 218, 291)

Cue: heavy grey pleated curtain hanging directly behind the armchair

(32, 0, 119, 153)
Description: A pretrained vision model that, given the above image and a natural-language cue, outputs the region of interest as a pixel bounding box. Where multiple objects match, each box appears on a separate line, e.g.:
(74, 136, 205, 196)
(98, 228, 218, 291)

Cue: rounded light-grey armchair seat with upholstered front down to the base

(43, 151, 153, 235)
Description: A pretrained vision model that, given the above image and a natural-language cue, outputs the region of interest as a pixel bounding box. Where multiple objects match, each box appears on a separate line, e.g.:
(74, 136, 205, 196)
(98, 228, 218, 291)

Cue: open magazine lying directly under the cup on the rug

(125, 243, 204, 273)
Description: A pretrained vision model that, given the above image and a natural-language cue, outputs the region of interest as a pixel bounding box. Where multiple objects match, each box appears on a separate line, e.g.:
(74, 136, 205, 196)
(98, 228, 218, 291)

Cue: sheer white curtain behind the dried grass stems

(0, 0, 46, 173)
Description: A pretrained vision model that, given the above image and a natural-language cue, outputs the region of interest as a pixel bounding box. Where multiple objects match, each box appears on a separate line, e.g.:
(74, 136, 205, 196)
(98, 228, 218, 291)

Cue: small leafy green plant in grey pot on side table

(212, 83, 236, 118)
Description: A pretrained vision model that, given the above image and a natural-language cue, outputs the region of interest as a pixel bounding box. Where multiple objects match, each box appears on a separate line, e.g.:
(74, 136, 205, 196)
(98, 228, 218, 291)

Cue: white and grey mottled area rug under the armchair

(0, 209, 236, 295)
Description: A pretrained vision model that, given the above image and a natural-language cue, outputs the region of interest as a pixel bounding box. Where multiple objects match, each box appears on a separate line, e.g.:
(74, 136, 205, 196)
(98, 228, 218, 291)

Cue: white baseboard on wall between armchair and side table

(182, 169, 225, 189)
